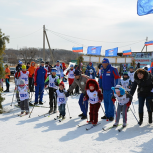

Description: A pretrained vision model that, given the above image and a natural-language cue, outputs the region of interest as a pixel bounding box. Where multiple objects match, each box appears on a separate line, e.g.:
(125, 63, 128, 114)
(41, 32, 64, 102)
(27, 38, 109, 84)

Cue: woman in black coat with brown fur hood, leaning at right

(130, 68, 153, 125)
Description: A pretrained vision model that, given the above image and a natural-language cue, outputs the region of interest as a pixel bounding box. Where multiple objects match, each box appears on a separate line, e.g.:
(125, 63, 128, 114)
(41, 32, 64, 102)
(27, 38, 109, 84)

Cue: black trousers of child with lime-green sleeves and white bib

(49, 88, 57, 110)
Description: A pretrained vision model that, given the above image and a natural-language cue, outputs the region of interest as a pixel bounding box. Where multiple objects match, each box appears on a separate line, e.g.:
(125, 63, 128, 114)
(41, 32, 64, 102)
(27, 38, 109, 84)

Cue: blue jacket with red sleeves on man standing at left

(34, 66, 47, 85)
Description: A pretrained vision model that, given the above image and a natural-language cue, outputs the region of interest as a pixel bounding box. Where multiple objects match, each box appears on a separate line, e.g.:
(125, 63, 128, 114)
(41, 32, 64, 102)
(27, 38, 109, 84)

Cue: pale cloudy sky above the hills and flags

(0, 0, 153, 55)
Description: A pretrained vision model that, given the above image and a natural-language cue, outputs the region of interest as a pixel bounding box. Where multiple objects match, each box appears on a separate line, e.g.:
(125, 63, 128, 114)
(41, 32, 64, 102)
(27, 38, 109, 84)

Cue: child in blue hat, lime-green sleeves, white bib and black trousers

(45, 68, 60, 113)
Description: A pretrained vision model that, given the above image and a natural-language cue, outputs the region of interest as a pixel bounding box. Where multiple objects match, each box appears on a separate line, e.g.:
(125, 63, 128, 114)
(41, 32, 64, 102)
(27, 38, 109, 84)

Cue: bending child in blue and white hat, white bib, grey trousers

(111, 85, 132, 127)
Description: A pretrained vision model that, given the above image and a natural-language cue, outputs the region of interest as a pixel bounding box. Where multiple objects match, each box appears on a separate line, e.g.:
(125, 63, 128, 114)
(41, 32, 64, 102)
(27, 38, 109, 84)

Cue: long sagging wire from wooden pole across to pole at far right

(46, 29, 145, 43)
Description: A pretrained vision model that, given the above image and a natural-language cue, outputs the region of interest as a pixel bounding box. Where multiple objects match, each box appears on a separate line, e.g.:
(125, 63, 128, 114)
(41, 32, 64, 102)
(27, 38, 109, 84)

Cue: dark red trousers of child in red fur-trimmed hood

(89, 103, 100, 124)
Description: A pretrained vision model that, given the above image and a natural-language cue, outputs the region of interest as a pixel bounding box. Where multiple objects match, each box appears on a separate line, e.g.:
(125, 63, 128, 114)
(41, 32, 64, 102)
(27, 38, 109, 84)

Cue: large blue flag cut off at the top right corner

(137, 0, 153, 16)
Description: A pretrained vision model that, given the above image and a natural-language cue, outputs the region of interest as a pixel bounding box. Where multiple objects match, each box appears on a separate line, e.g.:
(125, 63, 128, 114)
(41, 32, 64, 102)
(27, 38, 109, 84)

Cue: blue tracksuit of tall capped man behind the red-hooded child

(101, 64, 120, 118)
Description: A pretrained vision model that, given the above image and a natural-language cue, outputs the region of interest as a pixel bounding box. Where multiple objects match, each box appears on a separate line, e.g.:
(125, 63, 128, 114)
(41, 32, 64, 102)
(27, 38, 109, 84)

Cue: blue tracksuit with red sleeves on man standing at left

(34, 66, 47, 103)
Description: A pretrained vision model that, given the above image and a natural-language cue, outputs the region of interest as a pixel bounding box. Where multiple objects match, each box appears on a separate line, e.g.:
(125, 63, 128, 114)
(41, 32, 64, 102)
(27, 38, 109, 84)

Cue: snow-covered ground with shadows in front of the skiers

(0, 83, 153, 153)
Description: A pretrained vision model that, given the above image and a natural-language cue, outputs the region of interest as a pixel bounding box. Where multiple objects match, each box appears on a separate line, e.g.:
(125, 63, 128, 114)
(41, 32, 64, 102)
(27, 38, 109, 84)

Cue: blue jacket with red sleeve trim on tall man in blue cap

(101, 64, 120, 90)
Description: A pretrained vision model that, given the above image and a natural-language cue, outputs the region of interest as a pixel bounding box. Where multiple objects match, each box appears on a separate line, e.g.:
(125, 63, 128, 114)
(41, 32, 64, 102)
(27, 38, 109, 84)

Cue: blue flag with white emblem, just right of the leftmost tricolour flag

(87, 46, 102, 55)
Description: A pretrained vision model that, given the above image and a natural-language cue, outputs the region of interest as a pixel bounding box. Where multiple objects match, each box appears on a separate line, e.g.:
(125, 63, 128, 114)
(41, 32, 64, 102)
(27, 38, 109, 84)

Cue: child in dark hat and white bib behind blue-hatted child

(121, 72, 131, 92)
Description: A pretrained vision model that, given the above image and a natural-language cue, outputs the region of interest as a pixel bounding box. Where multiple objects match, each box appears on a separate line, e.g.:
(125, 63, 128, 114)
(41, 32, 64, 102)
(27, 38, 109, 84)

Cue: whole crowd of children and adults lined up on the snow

(0, 58, 153, 127)
